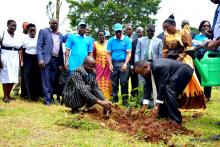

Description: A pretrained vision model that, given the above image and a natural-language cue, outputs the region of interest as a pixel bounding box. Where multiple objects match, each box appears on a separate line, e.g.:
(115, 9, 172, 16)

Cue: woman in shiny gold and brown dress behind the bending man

(162, 18, 206, 109)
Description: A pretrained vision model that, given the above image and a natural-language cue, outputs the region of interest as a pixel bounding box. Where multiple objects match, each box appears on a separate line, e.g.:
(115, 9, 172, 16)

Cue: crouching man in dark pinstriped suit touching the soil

(63, 56, 112, 115)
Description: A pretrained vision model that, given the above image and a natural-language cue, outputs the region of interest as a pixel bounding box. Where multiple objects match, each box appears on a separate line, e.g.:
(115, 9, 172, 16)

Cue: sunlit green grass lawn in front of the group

(0, 87, 220, 147)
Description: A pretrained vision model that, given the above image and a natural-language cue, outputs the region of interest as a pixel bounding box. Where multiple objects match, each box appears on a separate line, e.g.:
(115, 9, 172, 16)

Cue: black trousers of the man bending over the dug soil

(159, 65, 193, 123)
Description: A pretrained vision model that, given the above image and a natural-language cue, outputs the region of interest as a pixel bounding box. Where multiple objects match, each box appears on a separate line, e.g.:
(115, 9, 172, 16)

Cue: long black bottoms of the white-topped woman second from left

(24, 53, 42, 100)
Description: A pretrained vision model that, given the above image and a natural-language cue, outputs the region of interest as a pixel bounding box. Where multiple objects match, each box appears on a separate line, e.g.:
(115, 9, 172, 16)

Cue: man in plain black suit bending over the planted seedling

(134, 58, 193, 124)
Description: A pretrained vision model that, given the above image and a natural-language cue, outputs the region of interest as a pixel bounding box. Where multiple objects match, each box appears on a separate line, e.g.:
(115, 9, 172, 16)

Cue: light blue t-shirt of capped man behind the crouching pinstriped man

(65, 34, 92, 72)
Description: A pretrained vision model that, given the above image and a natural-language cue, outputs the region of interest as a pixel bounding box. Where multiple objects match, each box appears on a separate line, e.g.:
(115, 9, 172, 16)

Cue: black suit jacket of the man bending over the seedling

(144, 58, 194, 101)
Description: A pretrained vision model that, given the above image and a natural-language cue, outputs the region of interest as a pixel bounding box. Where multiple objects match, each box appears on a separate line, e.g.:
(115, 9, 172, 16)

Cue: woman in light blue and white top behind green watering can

(193, 20, 213, 101)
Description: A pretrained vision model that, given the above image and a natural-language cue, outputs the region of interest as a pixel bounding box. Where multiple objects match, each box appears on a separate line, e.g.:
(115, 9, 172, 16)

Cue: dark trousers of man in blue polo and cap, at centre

(111, 62, 129, 104)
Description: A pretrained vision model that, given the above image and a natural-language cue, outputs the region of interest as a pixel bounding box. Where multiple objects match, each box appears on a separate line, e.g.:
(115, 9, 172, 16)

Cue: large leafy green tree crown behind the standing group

(66, 0, 161, 36)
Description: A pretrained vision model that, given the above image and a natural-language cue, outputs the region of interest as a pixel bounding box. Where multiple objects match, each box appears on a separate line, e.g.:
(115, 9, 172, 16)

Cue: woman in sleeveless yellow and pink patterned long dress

(93, 30, 112, 100)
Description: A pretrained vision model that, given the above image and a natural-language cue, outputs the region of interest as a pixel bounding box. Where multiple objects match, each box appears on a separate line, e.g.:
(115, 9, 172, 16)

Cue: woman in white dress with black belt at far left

(0, 20, 22, 103)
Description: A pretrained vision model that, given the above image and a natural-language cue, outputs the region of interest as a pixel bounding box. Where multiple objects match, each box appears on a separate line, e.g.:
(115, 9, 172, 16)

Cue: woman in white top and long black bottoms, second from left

(23, 23, 42, 101)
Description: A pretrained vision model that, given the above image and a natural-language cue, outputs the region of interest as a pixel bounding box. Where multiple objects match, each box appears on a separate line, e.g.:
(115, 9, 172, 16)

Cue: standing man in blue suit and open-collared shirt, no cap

(37, 19, 64, 106)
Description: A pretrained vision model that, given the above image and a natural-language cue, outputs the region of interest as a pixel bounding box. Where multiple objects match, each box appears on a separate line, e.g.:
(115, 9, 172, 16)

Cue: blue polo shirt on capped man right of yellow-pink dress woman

(107, 36, 131, 61)
